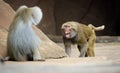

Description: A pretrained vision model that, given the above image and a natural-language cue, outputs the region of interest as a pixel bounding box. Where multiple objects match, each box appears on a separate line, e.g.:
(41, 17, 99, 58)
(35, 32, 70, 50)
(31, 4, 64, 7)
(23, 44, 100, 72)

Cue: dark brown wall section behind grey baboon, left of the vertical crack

(4, 0, 56, 35)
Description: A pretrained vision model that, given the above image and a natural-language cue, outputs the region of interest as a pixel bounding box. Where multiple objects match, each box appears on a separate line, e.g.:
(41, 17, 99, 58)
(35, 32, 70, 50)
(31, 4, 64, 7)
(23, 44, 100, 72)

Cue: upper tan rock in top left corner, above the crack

(0, 1, 15, 30)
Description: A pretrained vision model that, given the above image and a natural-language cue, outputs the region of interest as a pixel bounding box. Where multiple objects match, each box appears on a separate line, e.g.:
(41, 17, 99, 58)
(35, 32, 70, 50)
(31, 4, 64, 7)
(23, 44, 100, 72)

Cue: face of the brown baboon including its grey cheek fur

(62, 25, 77, 39)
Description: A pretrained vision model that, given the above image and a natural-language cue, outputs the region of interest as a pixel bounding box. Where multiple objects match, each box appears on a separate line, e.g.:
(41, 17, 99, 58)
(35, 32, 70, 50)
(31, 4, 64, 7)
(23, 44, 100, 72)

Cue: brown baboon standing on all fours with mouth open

(61, 21, 104, 57)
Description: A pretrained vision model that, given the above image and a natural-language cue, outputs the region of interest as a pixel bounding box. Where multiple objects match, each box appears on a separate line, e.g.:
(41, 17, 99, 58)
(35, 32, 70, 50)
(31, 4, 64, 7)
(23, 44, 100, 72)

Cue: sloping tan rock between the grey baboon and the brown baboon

(33, 25, 67, 58)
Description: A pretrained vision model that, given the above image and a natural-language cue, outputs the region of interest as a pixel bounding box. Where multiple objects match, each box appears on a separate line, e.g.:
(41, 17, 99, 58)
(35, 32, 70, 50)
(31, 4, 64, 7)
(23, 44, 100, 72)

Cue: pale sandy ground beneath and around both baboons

(0, 43, 120, 73)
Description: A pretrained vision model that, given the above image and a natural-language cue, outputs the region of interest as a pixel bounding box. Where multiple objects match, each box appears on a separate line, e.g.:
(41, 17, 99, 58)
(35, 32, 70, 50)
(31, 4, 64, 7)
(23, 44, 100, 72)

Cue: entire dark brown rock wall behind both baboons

(4, 0, 120, 36)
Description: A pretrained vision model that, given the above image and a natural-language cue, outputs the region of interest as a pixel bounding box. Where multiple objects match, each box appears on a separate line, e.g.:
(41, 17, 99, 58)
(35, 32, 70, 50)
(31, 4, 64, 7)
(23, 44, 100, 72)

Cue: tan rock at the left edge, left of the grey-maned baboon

(0, 0, 15, 57)
